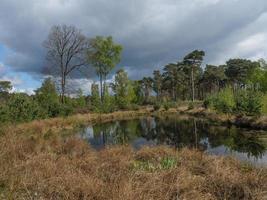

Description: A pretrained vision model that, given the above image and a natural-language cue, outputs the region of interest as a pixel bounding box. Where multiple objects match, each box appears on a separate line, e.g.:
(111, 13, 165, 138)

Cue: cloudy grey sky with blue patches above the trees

(0, 0, 267, 94)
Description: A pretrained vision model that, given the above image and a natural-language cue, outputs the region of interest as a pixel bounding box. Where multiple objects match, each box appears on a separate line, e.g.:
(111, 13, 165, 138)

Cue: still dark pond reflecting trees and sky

(78, 115, 267, 165)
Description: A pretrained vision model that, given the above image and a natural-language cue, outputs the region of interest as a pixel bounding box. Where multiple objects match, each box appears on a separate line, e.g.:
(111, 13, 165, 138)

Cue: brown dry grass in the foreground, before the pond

(0, 126, 267, 200)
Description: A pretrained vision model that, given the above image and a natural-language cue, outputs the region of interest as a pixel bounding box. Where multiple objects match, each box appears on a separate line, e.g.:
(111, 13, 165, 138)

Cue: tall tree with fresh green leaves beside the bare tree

(87, 36, 122, 102)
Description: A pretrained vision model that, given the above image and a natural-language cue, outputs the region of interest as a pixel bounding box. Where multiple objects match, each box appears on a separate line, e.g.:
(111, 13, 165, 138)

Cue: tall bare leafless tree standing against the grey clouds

(44, 25, 88, 103)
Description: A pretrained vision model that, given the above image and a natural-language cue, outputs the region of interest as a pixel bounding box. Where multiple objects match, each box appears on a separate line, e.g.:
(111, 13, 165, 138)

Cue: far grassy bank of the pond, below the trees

(5, 106, 267, 134)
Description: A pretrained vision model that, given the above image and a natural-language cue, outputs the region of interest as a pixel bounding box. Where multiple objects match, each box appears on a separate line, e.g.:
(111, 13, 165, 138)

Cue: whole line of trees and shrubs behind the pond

(0, 25, 267, 122)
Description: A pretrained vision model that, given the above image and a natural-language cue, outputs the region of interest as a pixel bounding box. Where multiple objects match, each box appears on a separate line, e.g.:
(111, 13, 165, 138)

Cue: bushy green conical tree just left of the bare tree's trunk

(35, 78, 60, 117)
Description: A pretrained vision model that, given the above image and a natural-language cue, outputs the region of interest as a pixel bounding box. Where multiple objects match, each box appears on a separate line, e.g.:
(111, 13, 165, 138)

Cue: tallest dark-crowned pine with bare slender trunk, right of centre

(184, 50, 205, 102)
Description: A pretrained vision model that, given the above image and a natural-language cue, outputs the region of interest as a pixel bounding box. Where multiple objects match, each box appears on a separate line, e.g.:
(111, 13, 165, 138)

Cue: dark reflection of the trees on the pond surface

(87, 116, 266, 158)
